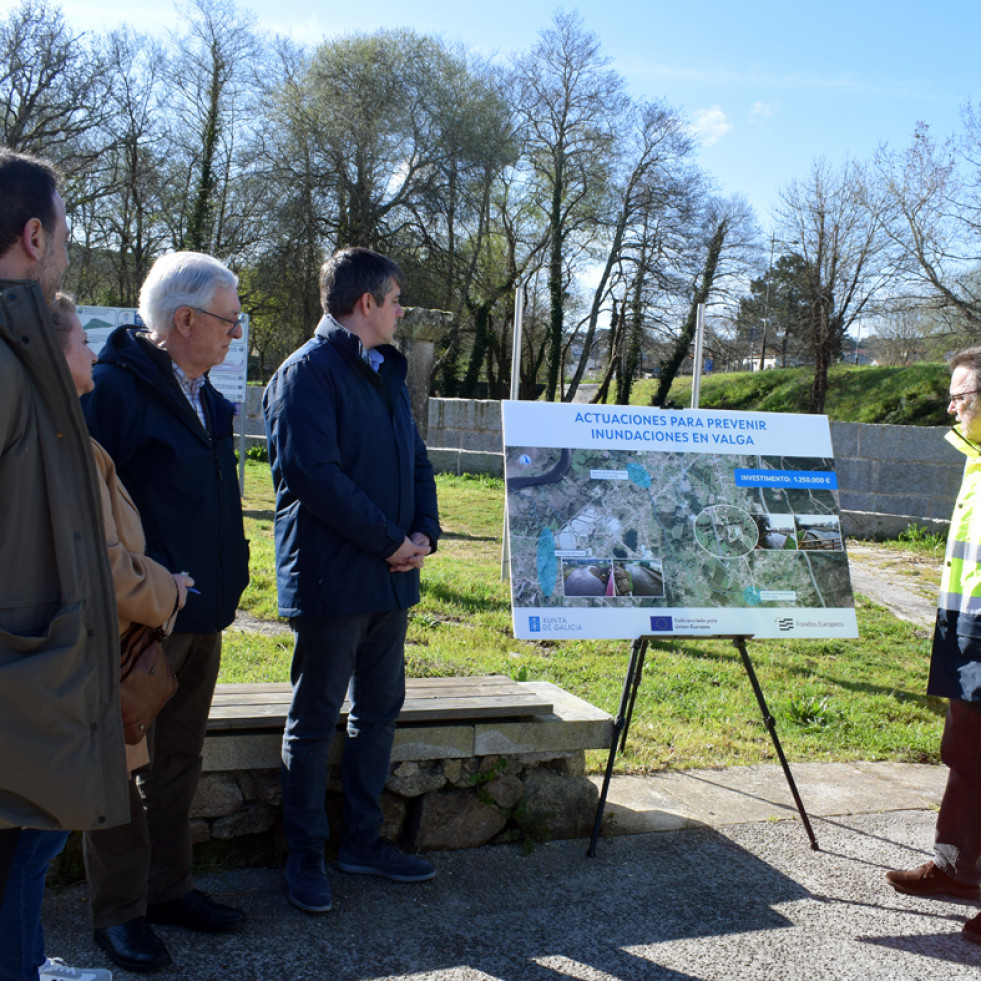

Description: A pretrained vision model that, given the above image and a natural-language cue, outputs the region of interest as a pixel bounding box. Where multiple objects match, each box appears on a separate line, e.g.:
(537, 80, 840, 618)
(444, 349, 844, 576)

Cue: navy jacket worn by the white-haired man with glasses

(82, 327, 249, 633)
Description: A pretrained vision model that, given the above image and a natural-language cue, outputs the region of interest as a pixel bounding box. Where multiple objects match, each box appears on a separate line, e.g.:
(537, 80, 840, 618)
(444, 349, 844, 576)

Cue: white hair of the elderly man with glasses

(140, 252, 238, 340)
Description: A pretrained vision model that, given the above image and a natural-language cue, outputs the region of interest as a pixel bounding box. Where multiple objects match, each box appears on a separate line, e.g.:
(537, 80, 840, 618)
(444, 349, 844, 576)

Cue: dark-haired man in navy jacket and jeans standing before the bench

(263, 248, 440, 912)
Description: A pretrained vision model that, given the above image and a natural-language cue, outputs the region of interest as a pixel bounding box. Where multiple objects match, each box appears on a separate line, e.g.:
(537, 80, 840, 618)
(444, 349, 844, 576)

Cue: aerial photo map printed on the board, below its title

(505, 400, 853, 636)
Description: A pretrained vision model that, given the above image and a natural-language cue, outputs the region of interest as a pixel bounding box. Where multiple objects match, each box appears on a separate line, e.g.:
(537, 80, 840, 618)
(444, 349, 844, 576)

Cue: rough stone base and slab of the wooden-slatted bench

(185, 681, 613, 850)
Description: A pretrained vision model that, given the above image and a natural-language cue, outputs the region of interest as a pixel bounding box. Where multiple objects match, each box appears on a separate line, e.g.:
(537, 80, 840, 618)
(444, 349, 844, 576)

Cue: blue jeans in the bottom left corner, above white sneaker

(0, 828, 68, 981)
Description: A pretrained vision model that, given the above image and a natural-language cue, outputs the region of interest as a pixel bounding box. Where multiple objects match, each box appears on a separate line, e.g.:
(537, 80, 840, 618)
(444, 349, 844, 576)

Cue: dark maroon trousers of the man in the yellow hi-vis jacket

(934, 698, 981, 884)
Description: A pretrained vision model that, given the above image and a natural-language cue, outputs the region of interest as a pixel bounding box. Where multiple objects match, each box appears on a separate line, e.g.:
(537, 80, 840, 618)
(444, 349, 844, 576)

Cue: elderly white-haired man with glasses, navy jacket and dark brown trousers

(82, 252, 248, 971)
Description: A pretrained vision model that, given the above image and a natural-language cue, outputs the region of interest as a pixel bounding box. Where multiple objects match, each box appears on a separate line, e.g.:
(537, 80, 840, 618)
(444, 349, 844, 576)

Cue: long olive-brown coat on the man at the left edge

(0, 282, 129, 829)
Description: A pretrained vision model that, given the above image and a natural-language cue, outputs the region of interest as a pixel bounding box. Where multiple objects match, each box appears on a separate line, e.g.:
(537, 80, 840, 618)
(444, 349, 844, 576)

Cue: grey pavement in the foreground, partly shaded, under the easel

(44, 763, 981, 981)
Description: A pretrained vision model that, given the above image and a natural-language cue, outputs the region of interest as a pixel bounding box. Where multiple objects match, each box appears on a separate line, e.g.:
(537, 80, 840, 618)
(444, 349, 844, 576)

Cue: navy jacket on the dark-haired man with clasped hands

(263, 318, 440, 617)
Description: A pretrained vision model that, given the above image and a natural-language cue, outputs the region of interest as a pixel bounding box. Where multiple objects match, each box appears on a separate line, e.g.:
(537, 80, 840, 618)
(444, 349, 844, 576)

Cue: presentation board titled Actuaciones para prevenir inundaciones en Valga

(502, 402, 858, 639)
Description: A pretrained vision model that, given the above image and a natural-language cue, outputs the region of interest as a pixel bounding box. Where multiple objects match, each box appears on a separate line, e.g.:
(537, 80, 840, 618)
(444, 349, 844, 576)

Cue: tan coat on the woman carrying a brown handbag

(92, 439, 177, 771)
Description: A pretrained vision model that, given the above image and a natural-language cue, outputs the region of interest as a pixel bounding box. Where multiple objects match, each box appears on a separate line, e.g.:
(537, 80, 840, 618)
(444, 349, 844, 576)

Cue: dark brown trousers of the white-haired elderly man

(84, 633, 221, 929)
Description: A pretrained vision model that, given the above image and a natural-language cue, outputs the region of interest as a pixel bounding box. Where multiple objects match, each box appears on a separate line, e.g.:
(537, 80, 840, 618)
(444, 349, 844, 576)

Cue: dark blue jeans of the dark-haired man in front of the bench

(281, 610, 408, 855)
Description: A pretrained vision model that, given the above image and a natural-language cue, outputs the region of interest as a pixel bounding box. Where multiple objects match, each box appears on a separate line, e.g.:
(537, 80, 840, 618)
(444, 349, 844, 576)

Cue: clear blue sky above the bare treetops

(55, 0, 981, 229)
